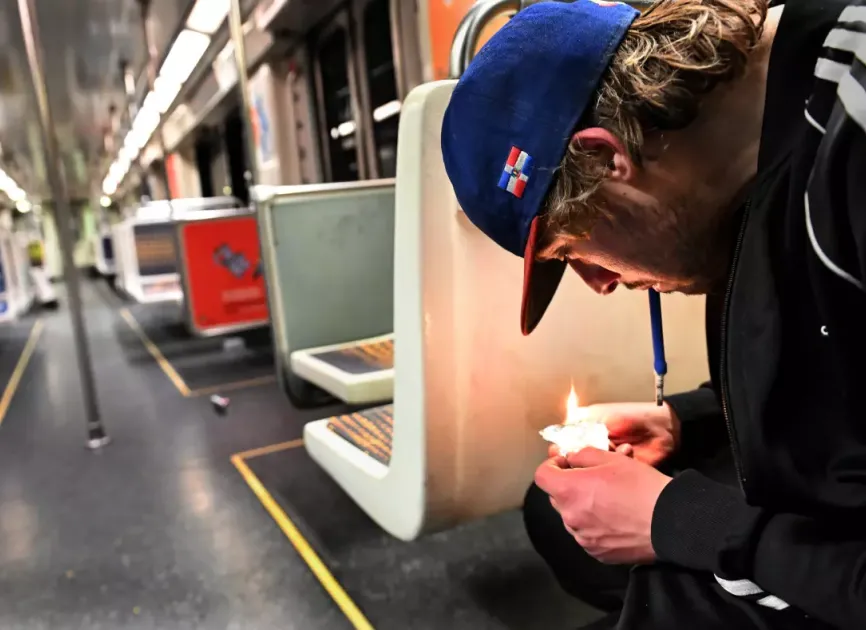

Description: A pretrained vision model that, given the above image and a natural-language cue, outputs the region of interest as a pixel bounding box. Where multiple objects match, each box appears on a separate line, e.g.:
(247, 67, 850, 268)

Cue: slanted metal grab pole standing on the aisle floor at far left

(18, 0, 109, 449)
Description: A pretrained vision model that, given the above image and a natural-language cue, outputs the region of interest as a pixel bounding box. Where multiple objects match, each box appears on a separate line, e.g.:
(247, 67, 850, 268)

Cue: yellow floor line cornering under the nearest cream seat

(231, 440, 374, 630)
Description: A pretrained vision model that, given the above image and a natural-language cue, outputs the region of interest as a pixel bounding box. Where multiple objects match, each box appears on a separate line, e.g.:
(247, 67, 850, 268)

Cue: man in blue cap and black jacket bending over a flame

(442, 0, 866, 630)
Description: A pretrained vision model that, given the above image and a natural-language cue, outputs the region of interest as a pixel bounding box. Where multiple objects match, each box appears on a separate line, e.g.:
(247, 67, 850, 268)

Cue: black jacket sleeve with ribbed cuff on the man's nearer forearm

(652, 470, 866, 630)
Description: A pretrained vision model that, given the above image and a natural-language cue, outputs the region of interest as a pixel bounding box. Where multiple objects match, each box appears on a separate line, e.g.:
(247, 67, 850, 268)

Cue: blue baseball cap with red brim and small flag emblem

(441, 0, 639, 335)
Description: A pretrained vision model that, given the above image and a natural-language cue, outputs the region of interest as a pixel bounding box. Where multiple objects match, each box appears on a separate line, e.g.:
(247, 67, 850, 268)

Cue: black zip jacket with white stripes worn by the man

(652, 0, 866, 629)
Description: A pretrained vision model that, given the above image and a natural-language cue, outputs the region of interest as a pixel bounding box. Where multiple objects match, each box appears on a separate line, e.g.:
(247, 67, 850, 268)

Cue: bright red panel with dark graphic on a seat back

(182, 216, 268, 331)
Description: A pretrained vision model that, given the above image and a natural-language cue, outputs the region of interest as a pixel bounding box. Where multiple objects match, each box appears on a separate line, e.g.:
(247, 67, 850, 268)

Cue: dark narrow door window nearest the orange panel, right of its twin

(363, 0, 400, 177)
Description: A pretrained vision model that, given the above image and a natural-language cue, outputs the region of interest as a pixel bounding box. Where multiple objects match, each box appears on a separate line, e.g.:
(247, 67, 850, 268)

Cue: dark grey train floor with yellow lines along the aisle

(0, 282, 598, 630)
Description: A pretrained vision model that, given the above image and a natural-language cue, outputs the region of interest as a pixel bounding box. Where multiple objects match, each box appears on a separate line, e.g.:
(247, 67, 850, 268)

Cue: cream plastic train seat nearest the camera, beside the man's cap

(304, 81, 707, 540)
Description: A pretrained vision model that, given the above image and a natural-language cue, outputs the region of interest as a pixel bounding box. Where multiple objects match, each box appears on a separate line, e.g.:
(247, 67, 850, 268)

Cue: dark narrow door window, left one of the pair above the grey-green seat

(318, 28, 358, 182)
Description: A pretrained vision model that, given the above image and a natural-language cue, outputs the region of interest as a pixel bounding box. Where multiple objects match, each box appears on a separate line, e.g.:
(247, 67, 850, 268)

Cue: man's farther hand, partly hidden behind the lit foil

(564, 403, 680, 466)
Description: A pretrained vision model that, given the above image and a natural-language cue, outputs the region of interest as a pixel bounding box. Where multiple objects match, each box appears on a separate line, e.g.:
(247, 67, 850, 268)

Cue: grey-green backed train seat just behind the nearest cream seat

(254, 180, 394, 404)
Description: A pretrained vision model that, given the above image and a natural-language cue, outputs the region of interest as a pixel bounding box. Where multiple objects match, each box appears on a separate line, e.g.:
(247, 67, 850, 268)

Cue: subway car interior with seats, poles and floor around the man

(0, 0, 707, 630)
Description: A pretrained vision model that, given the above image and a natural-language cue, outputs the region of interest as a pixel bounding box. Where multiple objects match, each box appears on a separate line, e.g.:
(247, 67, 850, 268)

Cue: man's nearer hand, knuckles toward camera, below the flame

(535, 448, 671, 564)
